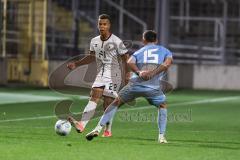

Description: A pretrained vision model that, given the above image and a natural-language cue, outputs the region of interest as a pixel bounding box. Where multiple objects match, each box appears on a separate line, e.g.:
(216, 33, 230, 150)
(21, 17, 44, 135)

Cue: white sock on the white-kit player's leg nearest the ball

(81, 101, 97, 128)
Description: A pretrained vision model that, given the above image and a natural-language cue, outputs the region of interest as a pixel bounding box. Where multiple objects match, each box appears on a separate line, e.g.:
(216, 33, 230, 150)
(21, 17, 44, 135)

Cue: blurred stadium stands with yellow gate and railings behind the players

(0, 0, 240, 90)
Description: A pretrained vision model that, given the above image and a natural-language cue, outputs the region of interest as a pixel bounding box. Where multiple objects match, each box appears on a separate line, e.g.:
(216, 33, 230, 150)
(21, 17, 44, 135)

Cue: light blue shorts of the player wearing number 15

(118, 83, 166, 107)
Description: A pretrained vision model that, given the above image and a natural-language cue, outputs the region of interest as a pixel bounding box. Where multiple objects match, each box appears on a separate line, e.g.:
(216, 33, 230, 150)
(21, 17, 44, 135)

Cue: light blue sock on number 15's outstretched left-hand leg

(99, 104, 118, 126)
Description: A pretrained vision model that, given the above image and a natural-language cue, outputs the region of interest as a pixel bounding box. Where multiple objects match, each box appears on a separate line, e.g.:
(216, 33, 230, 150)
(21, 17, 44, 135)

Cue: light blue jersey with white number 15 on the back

(130, 44, 172, 89)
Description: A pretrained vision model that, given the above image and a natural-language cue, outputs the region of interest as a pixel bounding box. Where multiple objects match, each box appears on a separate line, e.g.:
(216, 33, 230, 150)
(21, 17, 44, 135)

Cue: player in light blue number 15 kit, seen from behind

(86, 30, 172, 143)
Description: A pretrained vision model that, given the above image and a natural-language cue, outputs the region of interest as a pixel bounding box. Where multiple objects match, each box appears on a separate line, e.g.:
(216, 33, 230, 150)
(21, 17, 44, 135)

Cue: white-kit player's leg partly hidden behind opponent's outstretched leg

(102, 96, 114, 137)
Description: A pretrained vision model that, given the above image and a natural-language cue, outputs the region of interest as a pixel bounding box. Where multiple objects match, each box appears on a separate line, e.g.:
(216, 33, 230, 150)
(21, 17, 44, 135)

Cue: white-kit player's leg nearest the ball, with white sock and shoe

(68, 87, 104, 133)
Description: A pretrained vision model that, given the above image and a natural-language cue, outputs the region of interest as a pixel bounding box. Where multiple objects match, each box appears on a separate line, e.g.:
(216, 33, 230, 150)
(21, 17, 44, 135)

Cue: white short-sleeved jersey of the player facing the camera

(90, 34, 127, 78)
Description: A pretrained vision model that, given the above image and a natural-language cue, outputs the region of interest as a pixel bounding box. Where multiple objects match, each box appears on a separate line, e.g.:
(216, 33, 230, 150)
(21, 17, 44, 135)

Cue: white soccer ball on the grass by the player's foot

(55, 120, 72, 136)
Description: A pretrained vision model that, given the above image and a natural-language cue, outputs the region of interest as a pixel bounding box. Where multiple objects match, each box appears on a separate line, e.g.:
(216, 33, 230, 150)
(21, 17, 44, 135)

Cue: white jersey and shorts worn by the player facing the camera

(90, 34, 127, 98)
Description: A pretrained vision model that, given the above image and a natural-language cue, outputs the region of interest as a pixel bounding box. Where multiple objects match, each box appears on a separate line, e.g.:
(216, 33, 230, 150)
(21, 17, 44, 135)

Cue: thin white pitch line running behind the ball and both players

(0, 96, 240, 123)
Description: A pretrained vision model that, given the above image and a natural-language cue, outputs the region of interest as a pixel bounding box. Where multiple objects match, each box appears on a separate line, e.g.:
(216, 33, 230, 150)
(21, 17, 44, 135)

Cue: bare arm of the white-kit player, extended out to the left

(67, 51, 95, 70)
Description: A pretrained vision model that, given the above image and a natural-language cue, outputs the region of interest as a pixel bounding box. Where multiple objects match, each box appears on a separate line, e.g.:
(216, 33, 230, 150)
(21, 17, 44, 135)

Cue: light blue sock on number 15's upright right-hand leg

(158, 108, 167, 135)
